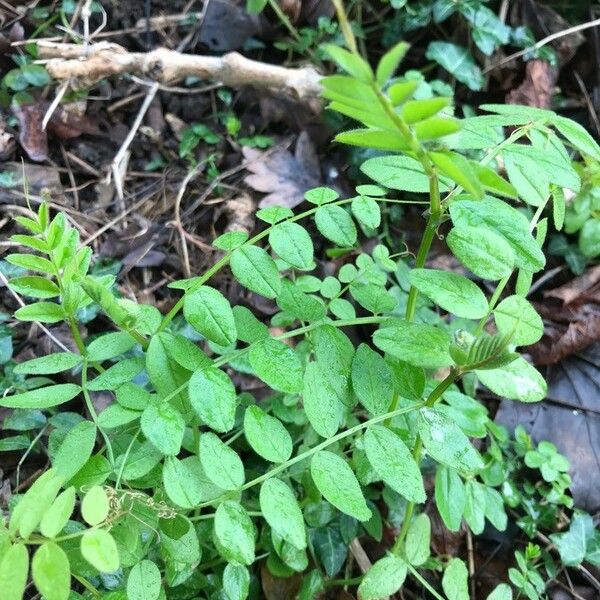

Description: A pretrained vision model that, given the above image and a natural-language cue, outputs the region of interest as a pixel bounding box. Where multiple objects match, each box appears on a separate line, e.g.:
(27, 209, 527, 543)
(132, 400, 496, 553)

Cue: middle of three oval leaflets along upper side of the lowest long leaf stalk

(244, 406, 293, 463)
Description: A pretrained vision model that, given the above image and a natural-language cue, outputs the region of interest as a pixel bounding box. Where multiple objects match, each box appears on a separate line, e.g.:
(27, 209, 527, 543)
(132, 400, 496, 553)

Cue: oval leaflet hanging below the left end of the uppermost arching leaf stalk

(183, 285, 237, 346)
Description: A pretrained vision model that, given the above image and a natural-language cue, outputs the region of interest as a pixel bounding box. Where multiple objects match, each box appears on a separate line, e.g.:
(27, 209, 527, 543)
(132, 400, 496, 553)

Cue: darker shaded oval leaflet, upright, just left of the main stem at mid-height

(352, 344, 394, 416)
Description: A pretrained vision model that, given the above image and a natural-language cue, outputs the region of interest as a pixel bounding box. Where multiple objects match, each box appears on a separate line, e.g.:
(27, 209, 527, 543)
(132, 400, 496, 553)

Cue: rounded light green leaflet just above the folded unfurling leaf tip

(494, 296, 544, 346)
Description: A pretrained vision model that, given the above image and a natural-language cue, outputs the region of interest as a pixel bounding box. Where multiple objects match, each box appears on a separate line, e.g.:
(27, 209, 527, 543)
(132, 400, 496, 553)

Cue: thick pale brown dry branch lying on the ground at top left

(38, 40, 321, 100)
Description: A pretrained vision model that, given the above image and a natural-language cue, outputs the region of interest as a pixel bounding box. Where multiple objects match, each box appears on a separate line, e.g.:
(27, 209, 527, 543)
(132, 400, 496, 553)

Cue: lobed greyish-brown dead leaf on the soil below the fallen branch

(243, 131, 321, 208)
